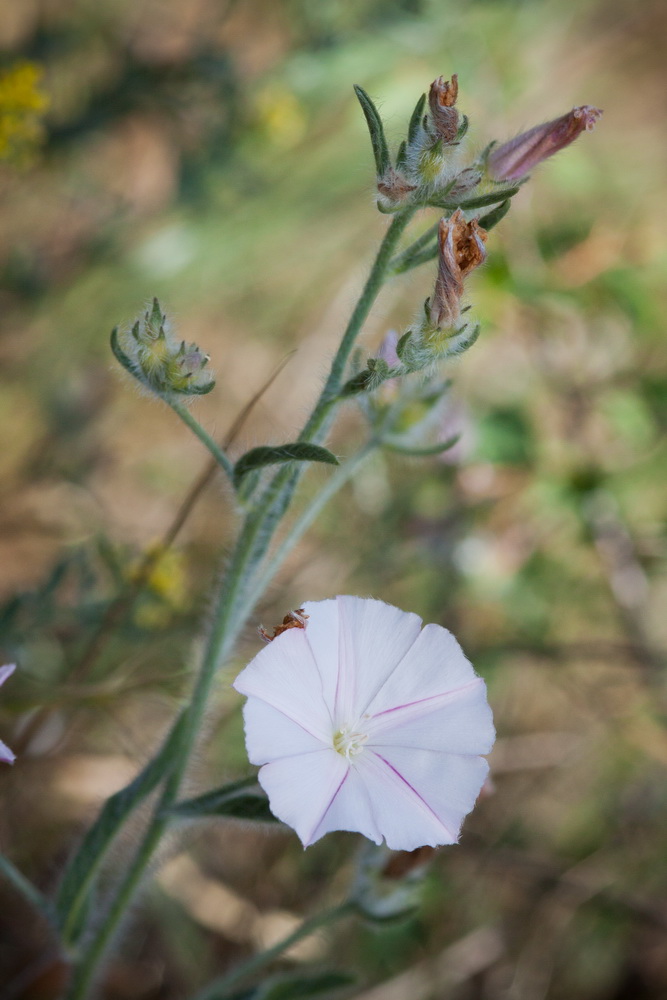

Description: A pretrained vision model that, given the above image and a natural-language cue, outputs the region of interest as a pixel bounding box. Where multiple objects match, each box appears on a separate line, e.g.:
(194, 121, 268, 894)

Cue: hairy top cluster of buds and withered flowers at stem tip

(350, 74, 602, 395)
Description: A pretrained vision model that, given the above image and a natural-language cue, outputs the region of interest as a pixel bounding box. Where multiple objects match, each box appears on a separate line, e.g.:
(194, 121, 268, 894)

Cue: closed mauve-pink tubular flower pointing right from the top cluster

(486, 104, 602, 181)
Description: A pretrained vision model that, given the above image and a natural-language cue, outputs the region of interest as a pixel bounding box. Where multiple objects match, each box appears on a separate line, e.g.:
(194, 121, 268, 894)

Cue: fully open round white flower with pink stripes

(234, 597, 494, 851)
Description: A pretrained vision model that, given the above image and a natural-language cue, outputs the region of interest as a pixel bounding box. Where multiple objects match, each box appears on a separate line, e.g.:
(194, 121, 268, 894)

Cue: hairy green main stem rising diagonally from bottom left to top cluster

(68, 208, 415, 1000)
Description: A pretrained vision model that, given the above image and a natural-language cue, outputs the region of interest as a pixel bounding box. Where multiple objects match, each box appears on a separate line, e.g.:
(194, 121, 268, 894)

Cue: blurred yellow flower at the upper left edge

(0, 62, 49, 166)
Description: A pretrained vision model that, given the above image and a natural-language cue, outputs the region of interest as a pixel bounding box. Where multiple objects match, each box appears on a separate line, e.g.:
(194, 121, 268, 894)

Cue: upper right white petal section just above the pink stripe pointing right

(366, 625, 477, 716)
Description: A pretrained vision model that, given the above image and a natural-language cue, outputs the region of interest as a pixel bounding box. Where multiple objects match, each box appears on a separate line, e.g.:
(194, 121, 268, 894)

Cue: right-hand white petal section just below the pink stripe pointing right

(366, 677, 495, 754)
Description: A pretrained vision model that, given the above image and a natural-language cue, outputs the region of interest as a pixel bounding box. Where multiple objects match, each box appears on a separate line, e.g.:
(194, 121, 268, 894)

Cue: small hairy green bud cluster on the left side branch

(111, 299, 215, 397)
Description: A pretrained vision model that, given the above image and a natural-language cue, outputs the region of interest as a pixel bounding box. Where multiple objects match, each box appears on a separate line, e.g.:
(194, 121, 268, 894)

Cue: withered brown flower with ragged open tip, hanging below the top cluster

(429, 209, 487, 327)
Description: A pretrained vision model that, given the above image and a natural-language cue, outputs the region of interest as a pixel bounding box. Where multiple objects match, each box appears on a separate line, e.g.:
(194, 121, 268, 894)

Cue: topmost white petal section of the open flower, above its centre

(335, 597, 421, 722)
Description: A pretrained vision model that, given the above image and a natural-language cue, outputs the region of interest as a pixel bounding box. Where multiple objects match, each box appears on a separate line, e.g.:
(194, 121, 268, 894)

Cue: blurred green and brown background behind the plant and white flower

(0, 0, 667, 1000)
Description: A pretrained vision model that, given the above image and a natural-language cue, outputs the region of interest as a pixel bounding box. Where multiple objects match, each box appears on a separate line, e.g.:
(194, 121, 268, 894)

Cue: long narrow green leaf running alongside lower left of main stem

(55, 712, 187, 944)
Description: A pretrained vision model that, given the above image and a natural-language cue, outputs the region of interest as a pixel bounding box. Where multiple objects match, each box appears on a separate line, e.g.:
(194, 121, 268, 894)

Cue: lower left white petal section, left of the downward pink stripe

(258, 749, 350, 847)
